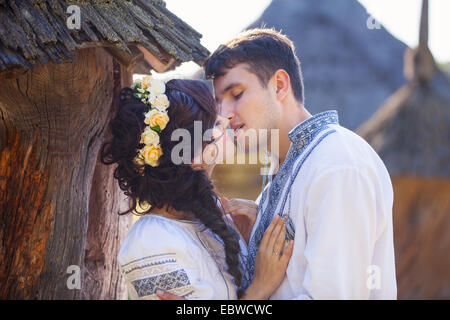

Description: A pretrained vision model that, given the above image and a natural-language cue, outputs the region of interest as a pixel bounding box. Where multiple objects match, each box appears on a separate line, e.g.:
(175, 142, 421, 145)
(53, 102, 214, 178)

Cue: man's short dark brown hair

(205, 28, 304, 102)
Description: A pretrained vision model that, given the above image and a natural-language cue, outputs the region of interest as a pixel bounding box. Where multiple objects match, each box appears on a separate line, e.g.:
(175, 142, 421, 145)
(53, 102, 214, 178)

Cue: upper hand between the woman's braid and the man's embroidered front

(220, 197, 258, 243)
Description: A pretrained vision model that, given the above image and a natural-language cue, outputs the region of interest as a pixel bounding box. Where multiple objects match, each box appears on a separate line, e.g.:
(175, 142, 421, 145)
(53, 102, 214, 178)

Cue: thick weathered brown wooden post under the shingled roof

(0, 48, 129, 299)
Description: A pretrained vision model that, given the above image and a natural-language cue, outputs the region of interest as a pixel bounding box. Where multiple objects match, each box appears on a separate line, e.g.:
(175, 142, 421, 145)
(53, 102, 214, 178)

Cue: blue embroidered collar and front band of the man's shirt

(243, 110, 339, 290)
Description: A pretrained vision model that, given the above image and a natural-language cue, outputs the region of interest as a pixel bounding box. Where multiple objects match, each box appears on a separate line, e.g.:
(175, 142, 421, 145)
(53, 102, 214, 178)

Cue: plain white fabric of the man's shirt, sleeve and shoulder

(253, 114, 397, 299)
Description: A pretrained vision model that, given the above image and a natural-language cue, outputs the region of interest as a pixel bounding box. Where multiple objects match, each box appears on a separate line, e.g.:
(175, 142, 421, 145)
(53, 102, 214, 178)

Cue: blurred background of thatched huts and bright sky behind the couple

(139, 0, 450, 299)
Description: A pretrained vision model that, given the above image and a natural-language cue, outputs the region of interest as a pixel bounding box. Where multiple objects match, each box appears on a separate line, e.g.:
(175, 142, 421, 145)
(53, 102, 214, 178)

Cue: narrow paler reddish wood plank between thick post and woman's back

(81, 61, 132, 299)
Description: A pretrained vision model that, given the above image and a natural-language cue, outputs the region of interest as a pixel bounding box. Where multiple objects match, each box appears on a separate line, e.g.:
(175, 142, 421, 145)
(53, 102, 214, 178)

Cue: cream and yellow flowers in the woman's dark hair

(131, 76, 170, 170)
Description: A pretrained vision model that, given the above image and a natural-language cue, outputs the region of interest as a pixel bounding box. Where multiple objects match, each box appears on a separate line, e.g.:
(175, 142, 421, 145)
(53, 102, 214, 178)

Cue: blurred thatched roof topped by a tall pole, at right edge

(357, 0, 450, 177)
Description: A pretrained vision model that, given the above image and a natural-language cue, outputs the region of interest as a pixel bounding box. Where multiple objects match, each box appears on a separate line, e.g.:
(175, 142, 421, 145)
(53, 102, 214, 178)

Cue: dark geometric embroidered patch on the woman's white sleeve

(132, 269, 191, 297)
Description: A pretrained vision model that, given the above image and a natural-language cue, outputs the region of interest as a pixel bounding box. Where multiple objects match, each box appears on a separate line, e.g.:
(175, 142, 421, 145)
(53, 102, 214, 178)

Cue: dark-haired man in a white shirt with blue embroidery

(159, 29, 397, 299)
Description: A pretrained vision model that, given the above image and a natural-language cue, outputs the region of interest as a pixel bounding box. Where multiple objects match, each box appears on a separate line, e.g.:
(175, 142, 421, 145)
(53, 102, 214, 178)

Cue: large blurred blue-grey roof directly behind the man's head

(249, 0, 406, 130)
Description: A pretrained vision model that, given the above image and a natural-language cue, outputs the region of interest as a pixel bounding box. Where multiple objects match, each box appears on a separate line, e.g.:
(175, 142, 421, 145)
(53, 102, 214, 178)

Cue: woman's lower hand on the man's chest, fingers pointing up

(242, 215, 294, 300)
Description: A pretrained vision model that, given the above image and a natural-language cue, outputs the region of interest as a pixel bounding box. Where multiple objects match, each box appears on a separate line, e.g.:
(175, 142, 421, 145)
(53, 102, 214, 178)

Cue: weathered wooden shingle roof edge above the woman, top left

(0, 0, 209, 72)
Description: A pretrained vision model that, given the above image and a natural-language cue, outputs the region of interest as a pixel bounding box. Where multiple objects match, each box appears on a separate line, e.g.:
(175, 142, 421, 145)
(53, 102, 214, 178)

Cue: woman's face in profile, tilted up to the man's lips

(203, 115, 235, 165)
